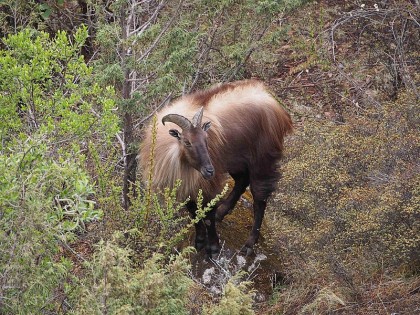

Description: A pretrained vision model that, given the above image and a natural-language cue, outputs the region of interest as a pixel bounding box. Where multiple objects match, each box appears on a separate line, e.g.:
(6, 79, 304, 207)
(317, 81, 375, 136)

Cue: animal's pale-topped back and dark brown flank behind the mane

(194, 80, 293, 172)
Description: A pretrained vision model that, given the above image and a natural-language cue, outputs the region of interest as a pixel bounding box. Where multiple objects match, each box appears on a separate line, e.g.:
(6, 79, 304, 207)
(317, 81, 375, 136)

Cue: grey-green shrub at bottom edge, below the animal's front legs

(73, 240, 193, 315)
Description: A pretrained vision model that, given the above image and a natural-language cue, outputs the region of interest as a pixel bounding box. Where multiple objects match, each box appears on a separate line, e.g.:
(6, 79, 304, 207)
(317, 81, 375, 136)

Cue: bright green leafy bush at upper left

(0, 28, 118, 148)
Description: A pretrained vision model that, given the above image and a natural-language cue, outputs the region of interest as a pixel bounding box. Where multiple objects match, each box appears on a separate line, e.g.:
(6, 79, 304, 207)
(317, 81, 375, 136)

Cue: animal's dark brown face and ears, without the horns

(169, 122, 214, 179)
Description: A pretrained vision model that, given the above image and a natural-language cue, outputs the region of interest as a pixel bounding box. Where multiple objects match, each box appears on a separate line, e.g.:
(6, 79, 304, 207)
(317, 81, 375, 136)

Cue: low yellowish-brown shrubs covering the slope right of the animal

(273, 88, 420, 293)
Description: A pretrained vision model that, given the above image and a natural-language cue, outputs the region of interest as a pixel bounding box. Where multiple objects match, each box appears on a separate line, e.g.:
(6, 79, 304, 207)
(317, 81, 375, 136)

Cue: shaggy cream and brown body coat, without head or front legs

(139, 80, 293, 256)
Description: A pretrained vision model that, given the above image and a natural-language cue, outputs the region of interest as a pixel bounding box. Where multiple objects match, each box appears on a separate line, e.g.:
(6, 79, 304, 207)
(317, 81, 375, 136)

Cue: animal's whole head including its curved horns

(162, 107, 214, 179)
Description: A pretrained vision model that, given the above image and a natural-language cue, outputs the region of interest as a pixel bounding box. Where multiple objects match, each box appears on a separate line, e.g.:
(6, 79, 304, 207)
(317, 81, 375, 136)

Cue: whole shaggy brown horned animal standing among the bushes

(140, 80, 293, 255)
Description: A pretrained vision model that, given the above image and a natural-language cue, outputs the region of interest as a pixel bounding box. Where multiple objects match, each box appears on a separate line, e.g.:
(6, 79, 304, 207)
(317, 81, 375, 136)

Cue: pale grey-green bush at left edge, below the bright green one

(0, 140, 97, 314)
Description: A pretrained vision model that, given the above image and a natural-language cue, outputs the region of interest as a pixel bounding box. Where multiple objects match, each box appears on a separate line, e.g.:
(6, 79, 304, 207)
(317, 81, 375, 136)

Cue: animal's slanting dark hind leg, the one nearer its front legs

(216, 172, 249, 221)
